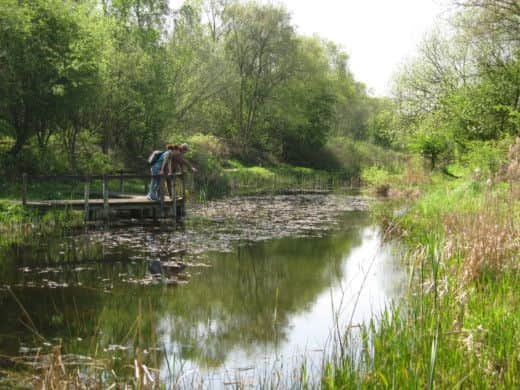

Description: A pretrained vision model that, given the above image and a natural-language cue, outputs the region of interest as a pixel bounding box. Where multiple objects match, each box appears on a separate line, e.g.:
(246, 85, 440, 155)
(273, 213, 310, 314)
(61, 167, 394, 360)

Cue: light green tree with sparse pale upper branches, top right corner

(394, 1, 520, 171)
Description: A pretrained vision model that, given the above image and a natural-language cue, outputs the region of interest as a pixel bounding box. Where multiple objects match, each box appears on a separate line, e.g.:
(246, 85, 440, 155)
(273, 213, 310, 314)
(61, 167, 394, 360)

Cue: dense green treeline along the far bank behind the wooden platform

(0, 0, 386, 172)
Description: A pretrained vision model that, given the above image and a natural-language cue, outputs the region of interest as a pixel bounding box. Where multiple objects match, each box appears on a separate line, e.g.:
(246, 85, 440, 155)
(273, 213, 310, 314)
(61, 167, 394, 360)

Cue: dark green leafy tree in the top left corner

(0, 0, 105, 161)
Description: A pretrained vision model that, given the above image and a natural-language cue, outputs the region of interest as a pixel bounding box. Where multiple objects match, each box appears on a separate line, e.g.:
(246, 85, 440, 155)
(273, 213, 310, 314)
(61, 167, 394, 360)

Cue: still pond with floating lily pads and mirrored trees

(0, 195, 404, 388)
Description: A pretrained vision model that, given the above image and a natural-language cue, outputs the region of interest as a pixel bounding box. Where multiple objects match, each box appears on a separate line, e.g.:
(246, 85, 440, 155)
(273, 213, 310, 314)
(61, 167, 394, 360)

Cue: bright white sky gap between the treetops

(171, 0, 447, 95)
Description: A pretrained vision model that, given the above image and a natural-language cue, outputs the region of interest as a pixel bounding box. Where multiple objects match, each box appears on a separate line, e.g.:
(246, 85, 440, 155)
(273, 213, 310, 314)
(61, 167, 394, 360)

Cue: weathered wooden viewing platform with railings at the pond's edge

(22, 173, 186, 221)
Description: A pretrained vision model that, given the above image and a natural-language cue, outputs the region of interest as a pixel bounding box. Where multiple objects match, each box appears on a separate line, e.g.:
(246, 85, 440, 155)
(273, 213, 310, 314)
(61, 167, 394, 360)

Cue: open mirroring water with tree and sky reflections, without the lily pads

(0, 195, 401, 387)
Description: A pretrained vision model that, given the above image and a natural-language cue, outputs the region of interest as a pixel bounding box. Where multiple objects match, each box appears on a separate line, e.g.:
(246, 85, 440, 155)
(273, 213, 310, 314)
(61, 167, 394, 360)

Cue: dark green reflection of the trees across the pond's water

(0, 213, 366, 367)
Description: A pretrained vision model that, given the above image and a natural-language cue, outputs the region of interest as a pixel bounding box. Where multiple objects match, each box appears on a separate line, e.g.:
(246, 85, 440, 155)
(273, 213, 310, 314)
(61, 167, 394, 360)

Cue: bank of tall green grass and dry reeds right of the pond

(323, 146, 520, 389)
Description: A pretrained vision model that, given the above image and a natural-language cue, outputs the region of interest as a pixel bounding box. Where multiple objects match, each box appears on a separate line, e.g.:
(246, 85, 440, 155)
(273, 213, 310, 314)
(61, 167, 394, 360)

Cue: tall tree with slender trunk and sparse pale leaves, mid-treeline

(224, 3, 296, 153)
